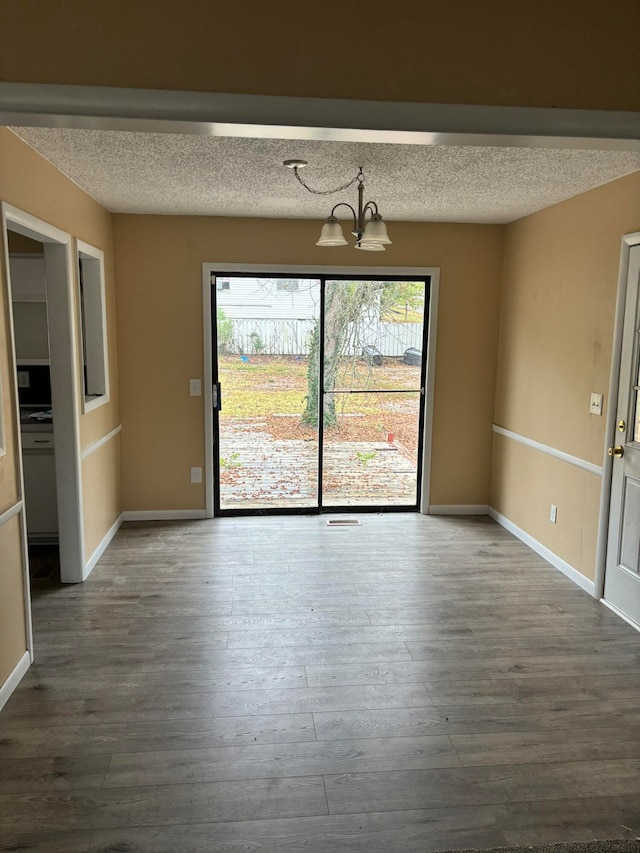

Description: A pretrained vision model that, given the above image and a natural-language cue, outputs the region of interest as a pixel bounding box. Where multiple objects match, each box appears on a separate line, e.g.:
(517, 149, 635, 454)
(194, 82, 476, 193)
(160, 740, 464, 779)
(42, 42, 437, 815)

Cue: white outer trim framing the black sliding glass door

(202, 262, 440, 518)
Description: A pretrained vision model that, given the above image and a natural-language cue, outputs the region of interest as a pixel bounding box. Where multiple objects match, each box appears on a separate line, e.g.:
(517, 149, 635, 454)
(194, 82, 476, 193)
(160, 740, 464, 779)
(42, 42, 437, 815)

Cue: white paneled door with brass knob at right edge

(604, 246, 640, 625)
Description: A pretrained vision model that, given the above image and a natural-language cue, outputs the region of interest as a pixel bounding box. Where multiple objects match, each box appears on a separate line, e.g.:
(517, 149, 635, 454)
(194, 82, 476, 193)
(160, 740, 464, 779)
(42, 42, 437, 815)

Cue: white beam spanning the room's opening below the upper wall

(0, 83, 640, 151)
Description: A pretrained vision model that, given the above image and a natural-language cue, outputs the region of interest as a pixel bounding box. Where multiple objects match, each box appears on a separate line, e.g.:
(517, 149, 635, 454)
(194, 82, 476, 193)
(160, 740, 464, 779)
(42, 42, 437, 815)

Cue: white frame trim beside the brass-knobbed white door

(593, 231, 640, 604)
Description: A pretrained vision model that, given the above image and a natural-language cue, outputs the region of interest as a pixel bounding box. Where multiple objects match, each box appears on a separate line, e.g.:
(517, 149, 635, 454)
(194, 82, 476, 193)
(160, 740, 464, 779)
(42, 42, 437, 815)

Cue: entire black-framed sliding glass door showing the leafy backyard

(209, 271, 430, 515)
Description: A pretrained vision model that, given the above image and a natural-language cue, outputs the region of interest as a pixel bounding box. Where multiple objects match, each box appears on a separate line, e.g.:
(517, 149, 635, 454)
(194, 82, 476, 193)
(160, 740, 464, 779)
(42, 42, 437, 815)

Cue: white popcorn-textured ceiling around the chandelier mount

(13, 128, 640, 223)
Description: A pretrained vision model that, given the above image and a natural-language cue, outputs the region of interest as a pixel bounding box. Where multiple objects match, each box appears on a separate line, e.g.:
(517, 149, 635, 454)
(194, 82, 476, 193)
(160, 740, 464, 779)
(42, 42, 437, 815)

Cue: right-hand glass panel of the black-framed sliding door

(322, 280, 425, 507)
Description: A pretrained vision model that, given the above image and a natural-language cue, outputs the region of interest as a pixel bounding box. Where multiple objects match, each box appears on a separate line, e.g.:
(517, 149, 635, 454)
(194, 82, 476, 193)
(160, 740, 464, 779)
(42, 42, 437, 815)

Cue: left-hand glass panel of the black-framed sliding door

(215, 276, 320, 510)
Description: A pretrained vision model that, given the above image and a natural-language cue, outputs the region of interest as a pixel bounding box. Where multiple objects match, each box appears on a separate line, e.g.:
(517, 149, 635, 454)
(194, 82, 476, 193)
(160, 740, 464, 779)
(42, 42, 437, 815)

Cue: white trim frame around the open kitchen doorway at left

(0, 202, 85, 592)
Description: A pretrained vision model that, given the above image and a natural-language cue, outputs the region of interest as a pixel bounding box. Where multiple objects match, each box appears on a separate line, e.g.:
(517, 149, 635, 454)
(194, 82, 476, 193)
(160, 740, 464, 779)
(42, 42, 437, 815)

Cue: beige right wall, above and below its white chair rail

(491, 172, 640, 578)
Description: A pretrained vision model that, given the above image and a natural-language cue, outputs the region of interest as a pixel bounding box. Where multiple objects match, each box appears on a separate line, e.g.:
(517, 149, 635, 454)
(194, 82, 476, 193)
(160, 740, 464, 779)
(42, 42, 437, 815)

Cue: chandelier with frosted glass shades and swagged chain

(283, 160, 391, 252)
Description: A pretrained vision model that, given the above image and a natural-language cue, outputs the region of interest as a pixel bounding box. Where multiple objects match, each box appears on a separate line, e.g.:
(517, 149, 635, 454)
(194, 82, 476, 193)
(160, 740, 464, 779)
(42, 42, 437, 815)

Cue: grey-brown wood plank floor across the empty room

(0, 515, 640, 853)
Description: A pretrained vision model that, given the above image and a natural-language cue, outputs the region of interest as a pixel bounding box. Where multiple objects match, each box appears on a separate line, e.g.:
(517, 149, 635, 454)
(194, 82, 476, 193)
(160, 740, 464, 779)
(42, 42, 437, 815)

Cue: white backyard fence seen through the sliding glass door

(220, 319, 422, 356)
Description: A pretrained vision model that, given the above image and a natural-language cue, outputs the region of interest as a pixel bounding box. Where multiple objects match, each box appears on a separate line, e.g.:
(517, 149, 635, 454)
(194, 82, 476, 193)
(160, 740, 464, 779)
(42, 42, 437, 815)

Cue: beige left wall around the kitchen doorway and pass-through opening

(0, 128, 120, 696)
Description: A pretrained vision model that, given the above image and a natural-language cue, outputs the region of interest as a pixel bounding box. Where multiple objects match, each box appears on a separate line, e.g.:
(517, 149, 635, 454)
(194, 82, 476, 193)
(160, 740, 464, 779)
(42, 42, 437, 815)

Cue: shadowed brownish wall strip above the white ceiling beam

(0, 0, 640, 110)
